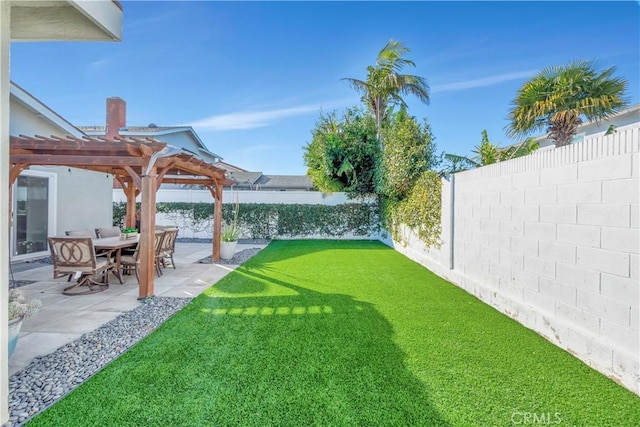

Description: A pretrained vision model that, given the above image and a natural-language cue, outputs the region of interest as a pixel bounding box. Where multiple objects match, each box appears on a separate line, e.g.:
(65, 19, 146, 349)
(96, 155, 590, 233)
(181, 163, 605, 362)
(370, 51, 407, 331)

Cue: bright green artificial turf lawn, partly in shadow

(29, 241, 640, 427)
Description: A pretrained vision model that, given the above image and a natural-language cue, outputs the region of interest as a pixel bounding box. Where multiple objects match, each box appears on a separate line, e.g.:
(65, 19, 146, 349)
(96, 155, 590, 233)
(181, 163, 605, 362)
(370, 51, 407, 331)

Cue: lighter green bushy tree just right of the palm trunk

(376, 108, 439, 200)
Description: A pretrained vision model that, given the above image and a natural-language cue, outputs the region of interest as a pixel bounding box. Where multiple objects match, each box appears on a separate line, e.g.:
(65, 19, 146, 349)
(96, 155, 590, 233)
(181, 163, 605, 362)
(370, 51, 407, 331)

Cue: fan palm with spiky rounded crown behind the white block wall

(506, 61, 628, 147)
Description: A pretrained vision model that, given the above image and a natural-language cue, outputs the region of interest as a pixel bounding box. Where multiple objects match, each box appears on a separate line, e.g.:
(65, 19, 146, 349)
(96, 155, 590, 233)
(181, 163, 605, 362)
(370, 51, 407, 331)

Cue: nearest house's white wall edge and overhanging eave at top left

(0, 0, 123, 423)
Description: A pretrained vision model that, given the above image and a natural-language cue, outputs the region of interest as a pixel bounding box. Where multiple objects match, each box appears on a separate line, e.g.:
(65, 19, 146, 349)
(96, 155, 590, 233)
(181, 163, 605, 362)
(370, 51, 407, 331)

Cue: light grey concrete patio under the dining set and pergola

(9, 242, 266, 375)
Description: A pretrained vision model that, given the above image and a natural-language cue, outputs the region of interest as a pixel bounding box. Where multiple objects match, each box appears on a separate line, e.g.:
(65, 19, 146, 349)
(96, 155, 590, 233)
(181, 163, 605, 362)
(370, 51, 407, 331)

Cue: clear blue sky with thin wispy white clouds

(11, 1, 640, 174)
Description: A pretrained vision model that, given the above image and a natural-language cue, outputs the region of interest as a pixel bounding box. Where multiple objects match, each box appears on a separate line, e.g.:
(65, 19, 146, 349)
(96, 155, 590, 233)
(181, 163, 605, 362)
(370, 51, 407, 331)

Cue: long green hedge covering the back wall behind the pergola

(113, 202, 380, 239)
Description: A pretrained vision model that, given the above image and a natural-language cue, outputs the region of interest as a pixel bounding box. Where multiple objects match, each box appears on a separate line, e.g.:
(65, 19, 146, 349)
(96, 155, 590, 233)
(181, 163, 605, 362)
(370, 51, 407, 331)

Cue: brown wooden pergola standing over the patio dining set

(9, 135, 230, 299)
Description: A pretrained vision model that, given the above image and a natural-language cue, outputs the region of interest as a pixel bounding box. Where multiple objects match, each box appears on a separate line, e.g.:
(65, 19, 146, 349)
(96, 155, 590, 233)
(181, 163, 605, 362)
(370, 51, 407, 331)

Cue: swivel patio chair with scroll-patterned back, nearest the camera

(47, 237, 116, 296)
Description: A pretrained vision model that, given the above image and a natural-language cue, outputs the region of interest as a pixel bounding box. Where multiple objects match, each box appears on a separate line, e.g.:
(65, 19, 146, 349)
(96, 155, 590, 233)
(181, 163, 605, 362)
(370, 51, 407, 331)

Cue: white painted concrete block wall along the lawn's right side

(384, 129, 640, 394)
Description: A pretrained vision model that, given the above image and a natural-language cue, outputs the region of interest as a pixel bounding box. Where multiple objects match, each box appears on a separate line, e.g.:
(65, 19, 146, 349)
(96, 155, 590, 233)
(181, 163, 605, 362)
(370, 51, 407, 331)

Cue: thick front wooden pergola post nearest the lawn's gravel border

(138, 167, 158, 299)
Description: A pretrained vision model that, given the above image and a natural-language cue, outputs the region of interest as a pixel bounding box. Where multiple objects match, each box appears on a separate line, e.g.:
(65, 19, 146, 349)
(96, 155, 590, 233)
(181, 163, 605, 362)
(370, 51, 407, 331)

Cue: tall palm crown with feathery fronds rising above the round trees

(342, 40, 429, 138)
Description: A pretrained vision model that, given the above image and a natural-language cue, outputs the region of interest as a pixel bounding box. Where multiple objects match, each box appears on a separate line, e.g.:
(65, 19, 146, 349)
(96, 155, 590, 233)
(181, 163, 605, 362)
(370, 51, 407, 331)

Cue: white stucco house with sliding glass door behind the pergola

(9, 82, 113, 261)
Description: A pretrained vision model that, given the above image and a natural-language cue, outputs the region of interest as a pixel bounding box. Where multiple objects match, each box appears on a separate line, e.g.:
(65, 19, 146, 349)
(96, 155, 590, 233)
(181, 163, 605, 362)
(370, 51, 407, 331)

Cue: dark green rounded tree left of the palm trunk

(304, 107, 379, 196)
